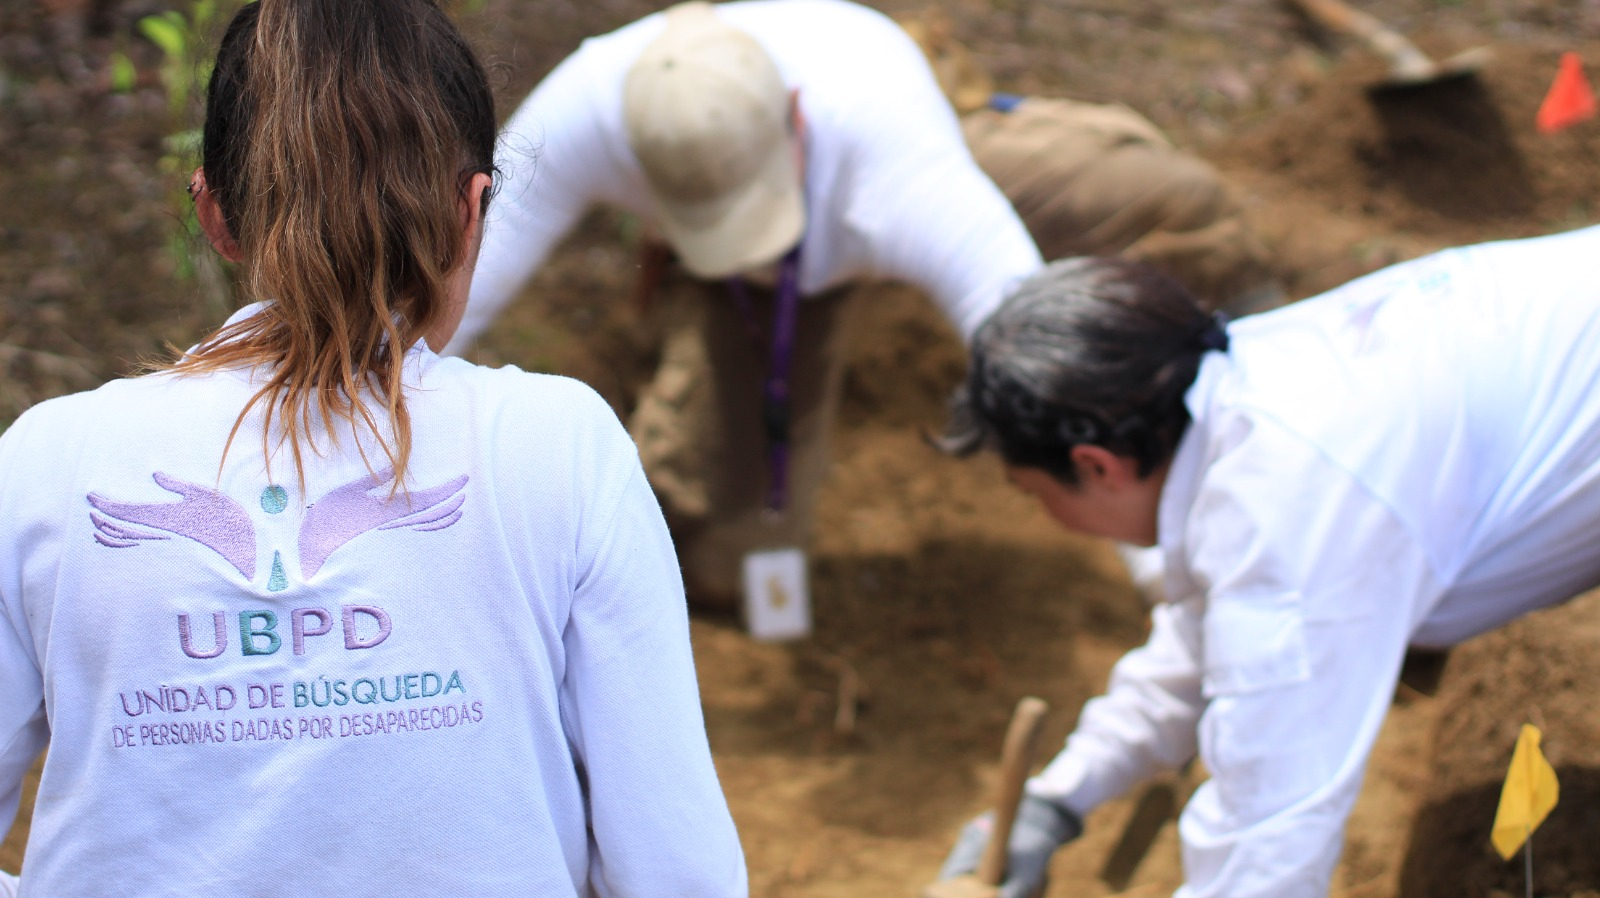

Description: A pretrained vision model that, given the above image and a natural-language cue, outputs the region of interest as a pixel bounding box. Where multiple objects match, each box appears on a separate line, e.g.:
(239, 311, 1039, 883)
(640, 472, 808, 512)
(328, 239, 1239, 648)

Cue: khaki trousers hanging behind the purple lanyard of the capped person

(629, 274, 851, 607)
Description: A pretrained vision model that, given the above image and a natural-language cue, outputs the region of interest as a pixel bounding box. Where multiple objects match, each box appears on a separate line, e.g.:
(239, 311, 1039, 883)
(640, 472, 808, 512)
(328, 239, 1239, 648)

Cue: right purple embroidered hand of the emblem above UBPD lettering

(299, 467, 467, 579)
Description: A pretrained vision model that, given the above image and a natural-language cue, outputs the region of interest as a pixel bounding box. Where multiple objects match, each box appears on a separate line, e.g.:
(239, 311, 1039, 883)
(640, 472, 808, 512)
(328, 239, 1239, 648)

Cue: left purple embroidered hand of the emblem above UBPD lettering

(88, 471, 256, 579)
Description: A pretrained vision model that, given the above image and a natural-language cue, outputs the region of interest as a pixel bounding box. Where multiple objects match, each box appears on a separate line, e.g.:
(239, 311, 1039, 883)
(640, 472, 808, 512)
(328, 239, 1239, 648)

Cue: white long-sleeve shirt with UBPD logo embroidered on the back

(0, 305, 746, 898)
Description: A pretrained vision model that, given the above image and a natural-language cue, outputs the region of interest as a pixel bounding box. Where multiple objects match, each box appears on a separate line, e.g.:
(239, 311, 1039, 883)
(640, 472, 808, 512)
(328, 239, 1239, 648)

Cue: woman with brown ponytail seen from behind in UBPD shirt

(0, 0, 746, 896)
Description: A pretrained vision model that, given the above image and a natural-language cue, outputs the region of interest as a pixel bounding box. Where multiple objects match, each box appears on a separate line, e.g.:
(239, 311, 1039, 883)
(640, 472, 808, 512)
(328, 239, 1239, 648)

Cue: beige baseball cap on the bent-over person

(622, 2, 805, 277)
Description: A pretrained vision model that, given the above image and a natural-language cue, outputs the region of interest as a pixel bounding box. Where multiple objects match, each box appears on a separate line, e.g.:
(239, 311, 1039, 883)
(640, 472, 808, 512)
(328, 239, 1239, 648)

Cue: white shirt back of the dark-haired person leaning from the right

(1203, 229, 1600, 645)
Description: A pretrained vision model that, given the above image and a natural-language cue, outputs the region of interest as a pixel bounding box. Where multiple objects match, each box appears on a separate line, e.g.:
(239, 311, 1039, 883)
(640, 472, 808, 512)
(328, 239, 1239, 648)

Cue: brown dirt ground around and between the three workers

(0, 0, 1600, 898)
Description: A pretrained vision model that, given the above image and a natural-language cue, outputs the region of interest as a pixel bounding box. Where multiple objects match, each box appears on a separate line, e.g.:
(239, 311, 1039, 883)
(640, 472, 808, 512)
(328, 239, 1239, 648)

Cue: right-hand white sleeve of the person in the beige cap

(832, 34, 1043, 339)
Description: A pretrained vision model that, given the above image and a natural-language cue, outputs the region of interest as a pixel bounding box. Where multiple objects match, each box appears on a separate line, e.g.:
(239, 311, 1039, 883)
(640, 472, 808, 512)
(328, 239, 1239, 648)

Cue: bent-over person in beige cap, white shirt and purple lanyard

(446, 0, 1043, 605)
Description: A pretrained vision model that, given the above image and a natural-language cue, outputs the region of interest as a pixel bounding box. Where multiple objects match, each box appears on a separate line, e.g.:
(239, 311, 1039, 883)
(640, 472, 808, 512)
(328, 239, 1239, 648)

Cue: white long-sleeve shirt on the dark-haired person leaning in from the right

(1029, 220, 1600, 898)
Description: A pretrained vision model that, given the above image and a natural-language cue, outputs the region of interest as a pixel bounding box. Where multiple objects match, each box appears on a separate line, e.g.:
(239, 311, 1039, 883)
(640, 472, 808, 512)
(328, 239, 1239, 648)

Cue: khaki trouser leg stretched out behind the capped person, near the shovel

(962, 98, 1274, 314)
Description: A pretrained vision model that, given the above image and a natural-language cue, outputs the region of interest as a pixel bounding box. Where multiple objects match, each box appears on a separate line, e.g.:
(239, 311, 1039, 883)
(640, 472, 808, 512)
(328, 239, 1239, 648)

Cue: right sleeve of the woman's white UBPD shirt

(562, 459, 747, 898)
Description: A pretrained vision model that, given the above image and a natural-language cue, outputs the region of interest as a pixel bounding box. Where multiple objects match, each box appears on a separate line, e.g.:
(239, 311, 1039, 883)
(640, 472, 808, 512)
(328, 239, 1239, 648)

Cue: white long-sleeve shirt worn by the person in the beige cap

(446, 0, 1042, 352)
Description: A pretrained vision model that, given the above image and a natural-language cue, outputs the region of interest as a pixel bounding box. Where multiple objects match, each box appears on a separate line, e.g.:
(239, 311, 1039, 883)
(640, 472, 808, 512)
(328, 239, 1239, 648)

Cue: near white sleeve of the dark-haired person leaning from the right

(1178, 419, 1438, 898)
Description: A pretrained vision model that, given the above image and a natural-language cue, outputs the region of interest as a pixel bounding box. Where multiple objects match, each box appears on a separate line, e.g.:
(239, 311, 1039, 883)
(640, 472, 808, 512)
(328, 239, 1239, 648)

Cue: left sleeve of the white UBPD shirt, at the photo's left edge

(0, 416, 50, 870)
